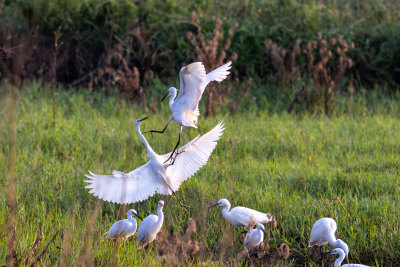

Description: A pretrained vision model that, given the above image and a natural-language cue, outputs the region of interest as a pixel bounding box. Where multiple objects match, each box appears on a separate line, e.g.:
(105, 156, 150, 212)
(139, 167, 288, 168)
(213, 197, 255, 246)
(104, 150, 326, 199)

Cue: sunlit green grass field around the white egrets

(0, 84, 400, 266)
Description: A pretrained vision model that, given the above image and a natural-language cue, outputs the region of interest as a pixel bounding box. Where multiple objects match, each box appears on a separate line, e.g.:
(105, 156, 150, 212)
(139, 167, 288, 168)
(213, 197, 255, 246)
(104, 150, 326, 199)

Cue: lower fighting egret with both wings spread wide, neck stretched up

(85, 117, 224, 204)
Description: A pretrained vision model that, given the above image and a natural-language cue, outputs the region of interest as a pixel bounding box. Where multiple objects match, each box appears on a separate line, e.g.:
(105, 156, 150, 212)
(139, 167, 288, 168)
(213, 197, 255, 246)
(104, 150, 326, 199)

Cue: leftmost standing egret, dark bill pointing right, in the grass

(104, 209, 143, 239)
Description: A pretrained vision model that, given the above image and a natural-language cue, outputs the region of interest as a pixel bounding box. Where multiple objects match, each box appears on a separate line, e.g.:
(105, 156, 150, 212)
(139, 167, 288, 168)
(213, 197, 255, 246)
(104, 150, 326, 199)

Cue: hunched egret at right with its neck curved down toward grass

(308, 218, 349, 257)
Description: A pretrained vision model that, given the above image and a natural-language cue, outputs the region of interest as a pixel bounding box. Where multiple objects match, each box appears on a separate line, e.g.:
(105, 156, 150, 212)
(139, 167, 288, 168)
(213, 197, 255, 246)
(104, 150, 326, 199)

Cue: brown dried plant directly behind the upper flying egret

(186, 12, 239, 116)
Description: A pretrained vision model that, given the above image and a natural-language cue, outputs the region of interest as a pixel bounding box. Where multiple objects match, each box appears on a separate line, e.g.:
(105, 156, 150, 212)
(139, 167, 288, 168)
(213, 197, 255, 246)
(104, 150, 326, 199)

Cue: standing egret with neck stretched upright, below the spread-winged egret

(136, 200, 164, 247)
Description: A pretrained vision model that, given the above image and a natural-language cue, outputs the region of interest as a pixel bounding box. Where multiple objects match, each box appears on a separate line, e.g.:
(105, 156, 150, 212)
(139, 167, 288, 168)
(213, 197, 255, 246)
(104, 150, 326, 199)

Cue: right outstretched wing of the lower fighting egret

(162, 122, 224, 191)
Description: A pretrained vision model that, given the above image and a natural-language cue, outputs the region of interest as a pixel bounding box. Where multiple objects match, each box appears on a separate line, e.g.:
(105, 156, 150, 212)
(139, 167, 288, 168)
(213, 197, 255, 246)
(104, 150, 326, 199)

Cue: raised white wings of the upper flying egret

(175, 61, 232, 111)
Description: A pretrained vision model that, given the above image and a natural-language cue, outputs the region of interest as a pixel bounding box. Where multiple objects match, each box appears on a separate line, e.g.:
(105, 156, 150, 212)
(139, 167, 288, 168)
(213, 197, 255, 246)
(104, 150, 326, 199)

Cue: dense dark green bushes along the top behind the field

(0, 0, 400, 90)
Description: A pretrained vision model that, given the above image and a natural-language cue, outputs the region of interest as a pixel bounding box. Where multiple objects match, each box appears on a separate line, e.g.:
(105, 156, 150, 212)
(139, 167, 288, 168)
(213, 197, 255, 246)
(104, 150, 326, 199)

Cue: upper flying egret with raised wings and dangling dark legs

(146, 61, 232, 164)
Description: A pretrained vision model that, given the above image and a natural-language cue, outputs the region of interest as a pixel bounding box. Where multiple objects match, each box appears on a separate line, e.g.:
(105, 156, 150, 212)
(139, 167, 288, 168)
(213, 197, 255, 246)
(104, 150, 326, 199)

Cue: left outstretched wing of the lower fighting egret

(85, 162, 162, 204)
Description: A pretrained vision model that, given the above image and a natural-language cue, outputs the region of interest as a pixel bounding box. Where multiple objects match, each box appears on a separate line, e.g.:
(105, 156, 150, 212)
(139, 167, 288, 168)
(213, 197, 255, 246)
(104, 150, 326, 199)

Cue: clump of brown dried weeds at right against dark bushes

(265, 33, 354, 114)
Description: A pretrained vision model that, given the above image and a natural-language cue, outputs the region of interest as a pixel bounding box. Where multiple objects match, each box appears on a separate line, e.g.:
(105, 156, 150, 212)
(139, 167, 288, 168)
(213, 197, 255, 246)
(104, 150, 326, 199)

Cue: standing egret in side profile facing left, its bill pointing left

(208, 198, 274, 227)
